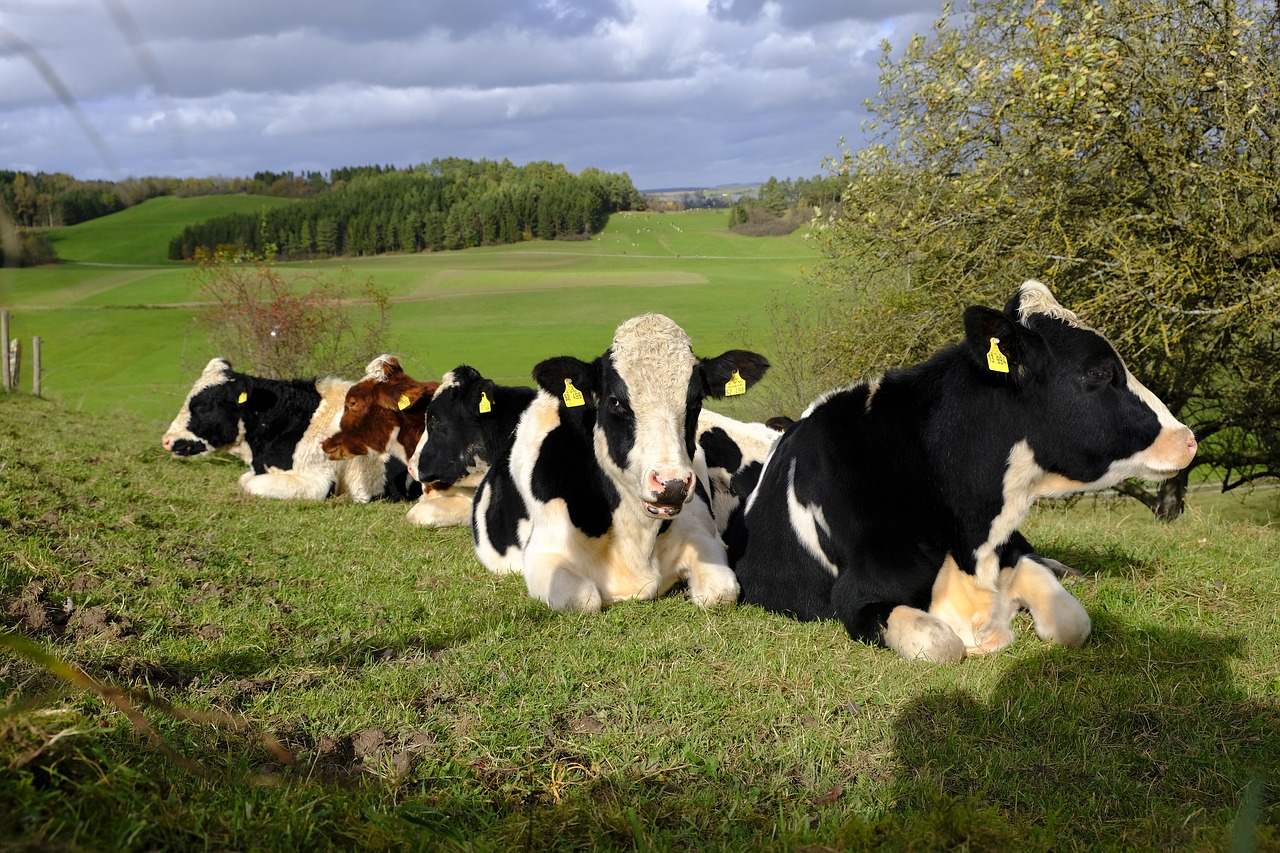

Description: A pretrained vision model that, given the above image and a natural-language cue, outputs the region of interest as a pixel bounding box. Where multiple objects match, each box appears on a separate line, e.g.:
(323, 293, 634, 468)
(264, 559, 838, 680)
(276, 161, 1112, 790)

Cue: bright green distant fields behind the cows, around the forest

(0, 196, 815, 428)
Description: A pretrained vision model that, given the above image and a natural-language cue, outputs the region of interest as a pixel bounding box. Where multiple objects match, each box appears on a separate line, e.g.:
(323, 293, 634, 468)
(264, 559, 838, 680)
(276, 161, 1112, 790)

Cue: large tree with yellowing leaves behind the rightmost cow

(814, 0, 1280, 519)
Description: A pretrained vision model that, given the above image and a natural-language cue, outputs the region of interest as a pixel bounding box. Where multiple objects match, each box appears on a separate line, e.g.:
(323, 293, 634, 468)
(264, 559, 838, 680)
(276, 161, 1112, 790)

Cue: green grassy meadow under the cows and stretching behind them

(0, 195, 1280, 852)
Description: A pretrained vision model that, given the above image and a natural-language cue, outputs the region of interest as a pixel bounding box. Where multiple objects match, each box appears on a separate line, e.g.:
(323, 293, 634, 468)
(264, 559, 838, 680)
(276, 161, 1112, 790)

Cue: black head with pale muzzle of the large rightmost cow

(964, 280, 1196, 493)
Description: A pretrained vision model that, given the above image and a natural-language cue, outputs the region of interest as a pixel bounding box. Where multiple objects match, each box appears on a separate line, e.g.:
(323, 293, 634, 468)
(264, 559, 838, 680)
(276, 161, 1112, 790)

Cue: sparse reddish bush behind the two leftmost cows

(192, 245, 390, 379)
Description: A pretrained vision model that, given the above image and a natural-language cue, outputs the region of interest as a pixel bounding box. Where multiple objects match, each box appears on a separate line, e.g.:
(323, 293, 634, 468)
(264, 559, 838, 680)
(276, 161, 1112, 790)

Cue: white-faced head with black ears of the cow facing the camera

(534, 314, 769, 519)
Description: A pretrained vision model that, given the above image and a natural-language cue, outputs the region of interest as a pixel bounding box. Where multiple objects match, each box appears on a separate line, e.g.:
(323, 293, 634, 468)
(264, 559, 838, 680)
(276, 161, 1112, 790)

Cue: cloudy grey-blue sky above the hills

(0, 0, 942, 191)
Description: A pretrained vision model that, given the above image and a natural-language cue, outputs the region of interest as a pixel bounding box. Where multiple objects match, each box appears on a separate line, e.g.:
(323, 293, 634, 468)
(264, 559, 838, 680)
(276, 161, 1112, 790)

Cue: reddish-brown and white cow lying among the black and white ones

(320, 355, 440, 502)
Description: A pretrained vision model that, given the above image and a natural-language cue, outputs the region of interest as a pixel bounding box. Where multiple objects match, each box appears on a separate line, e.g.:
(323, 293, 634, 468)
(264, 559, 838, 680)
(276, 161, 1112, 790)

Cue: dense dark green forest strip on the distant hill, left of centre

(169, 159, 644, 260)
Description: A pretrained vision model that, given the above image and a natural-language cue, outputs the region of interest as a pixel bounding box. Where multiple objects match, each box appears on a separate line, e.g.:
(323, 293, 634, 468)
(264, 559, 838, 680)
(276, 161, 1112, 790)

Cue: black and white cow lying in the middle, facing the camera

(486, 314, 768, 612)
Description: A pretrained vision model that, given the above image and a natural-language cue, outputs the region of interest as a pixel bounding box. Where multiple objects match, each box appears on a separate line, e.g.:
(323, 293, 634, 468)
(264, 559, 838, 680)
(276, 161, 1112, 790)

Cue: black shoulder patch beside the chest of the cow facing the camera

(531, 423, 622, 538)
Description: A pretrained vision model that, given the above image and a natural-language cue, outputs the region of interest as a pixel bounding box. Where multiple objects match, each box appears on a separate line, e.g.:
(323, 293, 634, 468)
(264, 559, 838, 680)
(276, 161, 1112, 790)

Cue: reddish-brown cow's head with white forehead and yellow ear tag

(320, 355, 434, 460)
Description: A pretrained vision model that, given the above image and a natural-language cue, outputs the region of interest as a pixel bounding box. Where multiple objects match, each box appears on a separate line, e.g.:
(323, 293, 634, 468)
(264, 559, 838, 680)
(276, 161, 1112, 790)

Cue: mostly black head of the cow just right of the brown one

(410, 365, 495, 489)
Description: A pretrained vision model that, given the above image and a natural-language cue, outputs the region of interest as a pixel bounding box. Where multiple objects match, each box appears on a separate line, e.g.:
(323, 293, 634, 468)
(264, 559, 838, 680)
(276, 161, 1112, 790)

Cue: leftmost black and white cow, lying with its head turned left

(160, 359, 387, 502)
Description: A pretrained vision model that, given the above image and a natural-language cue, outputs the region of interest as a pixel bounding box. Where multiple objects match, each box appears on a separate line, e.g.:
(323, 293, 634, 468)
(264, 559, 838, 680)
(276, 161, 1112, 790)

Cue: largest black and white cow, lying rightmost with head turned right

(728, 282, 1196, 661)
